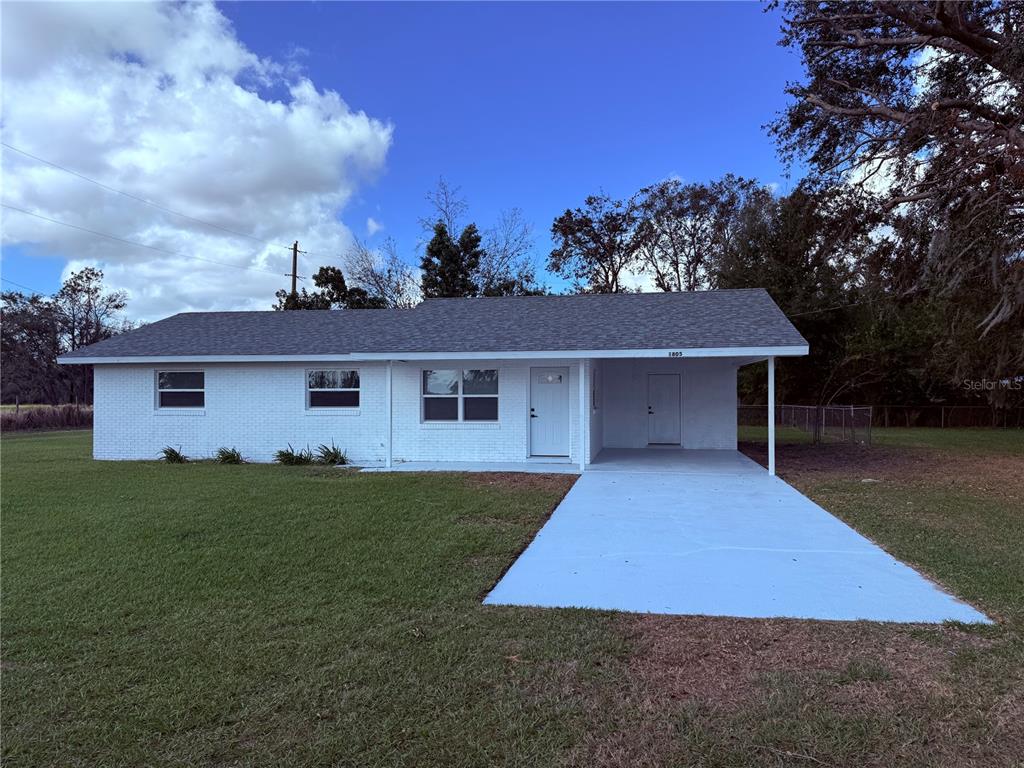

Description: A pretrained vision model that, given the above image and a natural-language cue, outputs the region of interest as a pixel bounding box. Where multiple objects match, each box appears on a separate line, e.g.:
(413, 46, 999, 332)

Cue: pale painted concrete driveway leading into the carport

(484, 451, 988, 622)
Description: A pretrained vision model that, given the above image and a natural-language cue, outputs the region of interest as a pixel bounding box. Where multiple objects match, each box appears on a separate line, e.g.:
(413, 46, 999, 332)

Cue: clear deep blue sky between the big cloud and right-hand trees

(3, 2, 800, 309)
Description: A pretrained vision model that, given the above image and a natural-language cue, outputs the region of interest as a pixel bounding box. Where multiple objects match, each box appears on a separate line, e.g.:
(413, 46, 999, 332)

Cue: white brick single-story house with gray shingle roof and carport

(60, 290, 807, 471)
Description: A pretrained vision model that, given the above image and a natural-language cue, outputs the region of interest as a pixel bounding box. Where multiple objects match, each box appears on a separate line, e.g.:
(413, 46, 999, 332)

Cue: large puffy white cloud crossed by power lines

(2, 3, 392, 319)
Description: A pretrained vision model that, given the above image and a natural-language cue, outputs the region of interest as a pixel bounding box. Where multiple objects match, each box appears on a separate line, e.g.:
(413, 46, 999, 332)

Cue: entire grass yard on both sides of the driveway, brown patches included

(6, 430, 1024, 768)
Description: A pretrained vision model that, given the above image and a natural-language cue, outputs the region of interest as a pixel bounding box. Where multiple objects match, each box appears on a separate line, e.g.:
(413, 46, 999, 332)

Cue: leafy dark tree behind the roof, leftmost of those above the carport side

(548, 194, 639, 293)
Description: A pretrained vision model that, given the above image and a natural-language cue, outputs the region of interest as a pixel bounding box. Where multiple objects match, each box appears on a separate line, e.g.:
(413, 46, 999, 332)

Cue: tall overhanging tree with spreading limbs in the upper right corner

(771, 0, 1024, 337)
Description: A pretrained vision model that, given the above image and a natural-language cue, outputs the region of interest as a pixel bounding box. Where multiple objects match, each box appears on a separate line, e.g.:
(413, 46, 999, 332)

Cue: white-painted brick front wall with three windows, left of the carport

(93, 360, 590, 464)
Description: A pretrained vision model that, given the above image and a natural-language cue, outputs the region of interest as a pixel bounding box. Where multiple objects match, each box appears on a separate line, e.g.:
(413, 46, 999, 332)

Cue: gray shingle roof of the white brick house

(58, 289, 807, 360)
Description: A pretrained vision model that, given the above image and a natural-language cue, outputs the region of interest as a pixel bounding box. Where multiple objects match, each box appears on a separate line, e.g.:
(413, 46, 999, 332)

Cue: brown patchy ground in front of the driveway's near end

(568, 615, 1024, 766)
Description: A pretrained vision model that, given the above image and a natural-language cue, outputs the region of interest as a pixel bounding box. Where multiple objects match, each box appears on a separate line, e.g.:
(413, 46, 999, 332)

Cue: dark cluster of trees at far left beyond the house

(0, 267, 132, 403)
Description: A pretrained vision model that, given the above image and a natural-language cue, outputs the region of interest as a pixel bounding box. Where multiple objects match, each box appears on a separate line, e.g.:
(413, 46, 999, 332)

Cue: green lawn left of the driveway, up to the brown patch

(2, 433, 622, 766)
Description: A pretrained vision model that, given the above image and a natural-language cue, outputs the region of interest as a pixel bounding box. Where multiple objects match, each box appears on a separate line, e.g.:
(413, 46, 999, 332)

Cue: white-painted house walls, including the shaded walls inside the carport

(93, 358, 739, 464)
